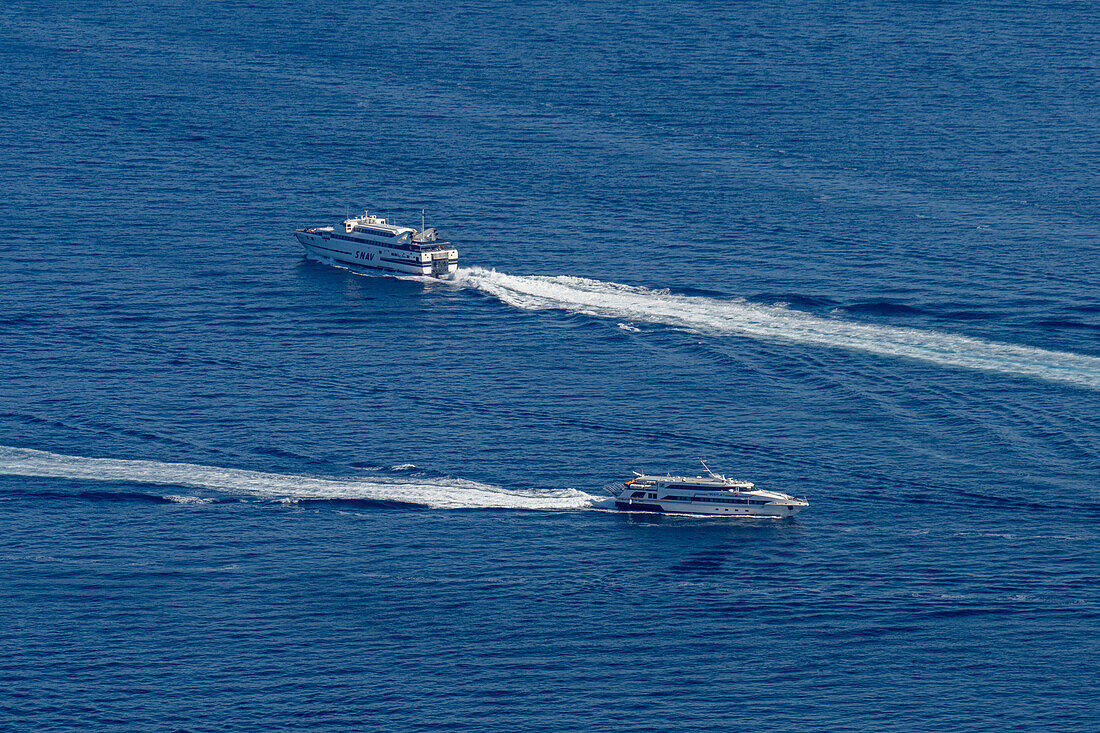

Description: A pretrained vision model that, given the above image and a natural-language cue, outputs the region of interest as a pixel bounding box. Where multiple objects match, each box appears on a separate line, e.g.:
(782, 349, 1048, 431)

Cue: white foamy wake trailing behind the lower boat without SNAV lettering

(0, 446, 598, 510)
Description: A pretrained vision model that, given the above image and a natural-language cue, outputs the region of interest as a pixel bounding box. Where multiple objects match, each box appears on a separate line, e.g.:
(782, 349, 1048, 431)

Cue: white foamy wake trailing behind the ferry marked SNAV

(455, 267, 1100, 390)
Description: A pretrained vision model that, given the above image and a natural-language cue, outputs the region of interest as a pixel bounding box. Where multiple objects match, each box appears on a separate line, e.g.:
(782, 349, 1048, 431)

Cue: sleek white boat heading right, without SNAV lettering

(612, 461, 810, 518)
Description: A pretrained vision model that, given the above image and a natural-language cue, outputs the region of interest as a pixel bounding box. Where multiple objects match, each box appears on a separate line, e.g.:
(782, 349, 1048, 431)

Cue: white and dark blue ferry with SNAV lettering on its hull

(294, 211, 459, 277)
